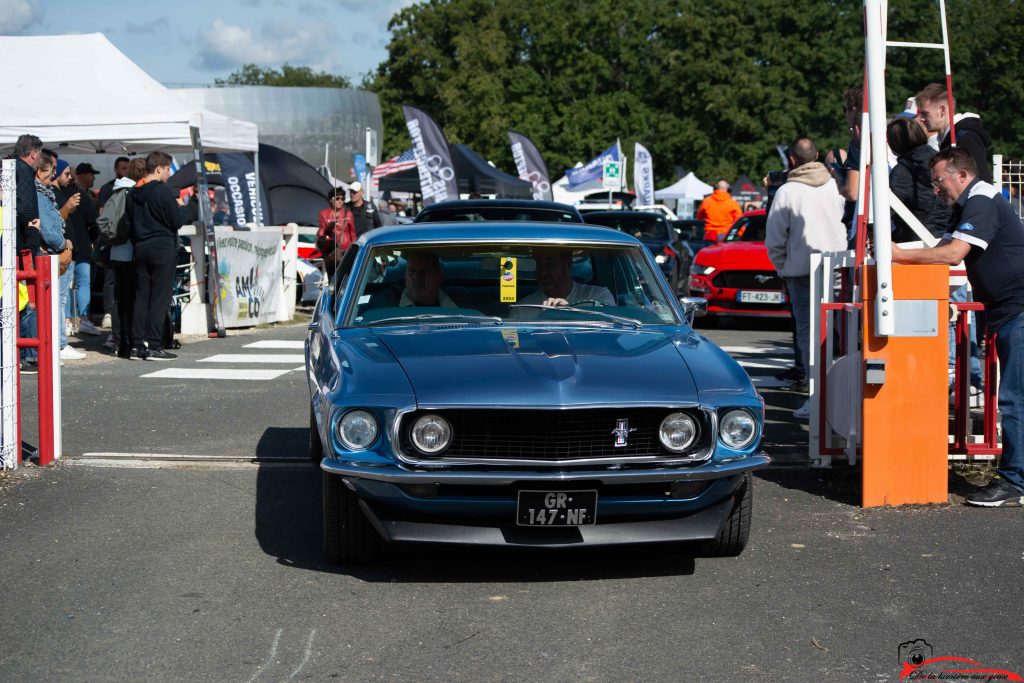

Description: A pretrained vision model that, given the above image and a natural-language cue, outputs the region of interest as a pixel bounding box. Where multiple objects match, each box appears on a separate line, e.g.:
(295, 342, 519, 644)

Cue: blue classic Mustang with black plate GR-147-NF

(306, 222, 769, 564)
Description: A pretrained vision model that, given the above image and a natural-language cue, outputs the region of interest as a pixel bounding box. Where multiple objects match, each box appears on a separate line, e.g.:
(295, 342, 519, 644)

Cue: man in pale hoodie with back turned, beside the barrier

(765, 137, 847, 418)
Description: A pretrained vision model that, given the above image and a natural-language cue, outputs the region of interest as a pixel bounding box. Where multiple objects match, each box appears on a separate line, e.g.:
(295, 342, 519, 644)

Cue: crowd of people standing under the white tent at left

(14, 135, 193, 366)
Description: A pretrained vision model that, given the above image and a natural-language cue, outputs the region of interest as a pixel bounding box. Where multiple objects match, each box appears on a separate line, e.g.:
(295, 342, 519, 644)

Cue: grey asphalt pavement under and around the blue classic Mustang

(0, 317, 1024, 682)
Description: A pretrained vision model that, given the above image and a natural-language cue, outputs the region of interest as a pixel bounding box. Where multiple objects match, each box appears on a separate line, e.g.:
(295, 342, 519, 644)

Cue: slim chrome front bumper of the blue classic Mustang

(321, 453, 771, 486)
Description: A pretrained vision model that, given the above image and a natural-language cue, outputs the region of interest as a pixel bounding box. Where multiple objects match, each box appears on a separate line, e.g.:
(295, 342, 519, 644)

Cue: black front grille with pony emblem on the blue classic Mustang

(398, 408, 712, 463)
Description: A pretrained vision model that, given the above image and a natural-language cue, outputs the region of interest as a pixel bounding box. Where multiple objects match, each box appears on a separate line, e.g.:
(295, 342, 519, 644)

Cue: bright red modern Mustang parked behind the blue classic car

(690, 209, 790, 325)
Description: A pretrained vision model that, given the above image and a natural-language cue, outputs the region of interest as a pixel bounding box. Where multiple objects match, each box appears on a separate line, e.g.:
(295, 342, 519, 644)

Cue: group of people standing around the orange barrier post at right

(765, 83, 1024, 507)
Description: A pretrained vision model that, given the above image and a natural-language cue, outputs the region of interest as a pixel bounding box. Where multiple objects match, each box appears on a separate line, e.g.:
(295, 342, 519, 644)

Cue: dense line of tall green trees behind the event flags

(218, 0, 1024, 184)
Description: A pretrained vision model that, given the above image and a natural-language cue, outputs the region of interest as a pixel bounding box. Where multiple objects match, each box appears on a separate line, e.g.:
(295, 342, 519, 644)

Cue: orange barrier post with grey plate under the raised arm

(861, 264, 949, 507)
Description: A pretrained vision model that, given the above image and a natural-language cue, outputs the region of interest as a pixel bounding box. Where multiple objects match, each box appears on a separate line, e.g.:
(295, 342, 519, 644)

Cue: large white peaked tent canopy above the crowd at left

(0, 34, 258, 155)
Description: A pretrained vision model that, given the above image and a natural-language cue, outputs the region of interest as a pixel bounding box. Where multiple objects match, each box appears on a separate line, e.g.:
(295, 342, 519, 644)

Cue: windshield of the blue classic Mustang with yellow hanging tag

(343, 243, 679, 328)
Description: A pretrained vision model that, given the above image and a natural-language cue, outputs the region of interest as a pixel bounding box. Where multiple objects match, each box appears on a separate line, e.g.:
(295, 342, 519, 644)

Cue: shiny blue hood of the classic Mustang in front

(376, 327, 697, 408)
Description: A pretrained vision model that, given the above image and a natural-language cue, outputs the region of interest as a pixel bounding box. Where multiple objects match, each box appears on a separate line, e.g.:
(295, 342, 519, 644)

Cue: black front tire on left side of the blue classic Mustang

(324, 472, 383, 564)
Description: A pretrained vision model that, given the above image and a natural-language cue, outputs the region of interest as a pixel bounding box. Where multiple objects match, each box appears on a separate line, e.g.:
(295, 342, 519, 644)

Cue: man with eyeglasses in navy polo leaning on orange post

(892, 147, 1024, 507)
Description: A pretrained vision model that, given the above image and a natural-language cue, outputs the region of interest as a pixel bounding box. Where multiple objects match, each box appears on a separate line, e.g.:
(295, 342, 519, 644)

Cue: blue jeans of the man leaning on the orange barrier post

(995, 313, 1024, 494)
